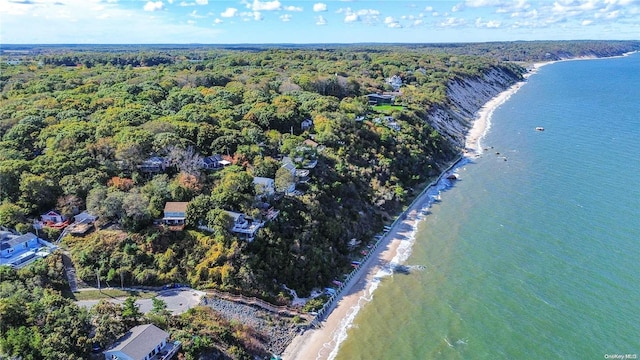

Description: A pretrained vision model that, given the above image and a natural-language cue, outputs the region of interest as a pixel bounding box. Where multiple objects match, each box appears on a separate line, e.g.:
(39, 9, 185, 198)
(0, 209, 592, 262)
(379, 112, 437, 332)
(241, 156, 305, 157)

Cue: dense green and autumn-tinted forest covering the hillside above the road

(0, 42, 638, 301)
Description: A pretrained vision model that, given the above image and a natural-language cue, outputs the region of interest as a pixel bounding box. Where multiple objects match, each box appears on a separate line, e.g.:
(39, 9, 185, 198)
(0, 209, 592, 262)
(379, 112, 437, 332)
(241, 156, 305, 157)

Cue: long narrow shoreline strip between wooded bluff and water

(282, 76, 532, 360)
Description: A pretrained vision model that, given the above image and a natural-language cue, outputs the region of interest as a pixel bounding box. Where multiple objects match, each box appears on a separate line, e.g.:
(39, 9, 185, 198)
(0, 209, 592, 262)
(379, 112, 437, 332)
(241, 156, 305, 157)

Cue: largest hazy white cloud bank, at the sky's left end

(0, 0, 221, 44)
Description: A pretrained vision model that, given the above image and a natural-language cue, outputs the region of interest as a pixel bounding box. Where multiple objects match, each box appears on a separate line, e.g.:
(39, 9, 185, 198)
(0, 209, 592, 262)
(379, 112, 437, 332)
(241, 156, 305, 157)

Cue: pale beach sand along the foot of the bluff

(282, 62, 551, 360)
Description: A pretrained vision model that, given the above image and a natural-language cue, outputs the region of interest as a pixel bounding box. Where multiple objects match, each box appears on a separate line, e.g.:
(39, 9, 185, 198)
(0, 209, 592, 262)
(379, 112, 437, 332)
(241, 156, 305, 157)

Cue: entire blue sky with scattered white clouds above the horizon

(0, 0, 640, 47)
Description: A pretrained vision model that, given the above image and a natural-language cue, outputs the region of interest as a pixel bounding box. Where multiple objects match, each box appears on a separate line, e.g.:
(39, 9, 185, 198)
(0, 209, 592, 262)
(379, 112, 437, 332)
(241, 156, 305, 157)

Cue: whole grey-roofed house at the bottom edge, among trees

(103, 324, 181, 360)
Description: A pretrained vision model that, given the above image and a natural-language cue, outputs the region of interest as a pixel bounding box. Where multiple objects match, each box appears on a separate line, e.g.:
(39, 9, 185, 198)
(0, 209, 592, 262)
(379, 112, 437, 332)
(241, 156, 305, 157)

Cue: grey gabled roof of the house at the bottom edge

(107, 324, 169, 359)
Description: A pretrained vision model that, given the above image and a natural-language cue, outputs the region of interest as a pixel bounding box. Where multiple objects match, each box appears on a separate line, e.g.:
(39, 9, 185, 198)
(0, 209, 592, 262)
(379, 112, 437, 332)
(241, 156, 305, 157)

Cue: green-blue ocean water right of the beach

(336, 54, 640, 360)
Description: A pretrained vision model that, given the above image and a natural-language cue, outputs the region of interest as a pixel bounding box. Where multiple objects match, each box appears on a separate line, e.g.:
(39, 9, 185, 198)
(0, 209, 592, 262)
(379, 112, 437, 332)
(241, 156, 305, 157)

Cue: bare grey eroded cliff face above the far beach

(427, 66, 522, 149)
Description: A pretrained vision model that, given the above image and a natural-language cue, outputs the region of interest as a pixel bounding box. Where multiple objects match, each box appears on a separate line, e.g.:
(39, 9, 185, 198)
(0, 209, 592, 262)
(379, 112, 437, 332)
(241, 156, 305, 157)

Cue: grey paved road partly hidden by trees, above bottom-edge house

(76, 288, 205, 315)
